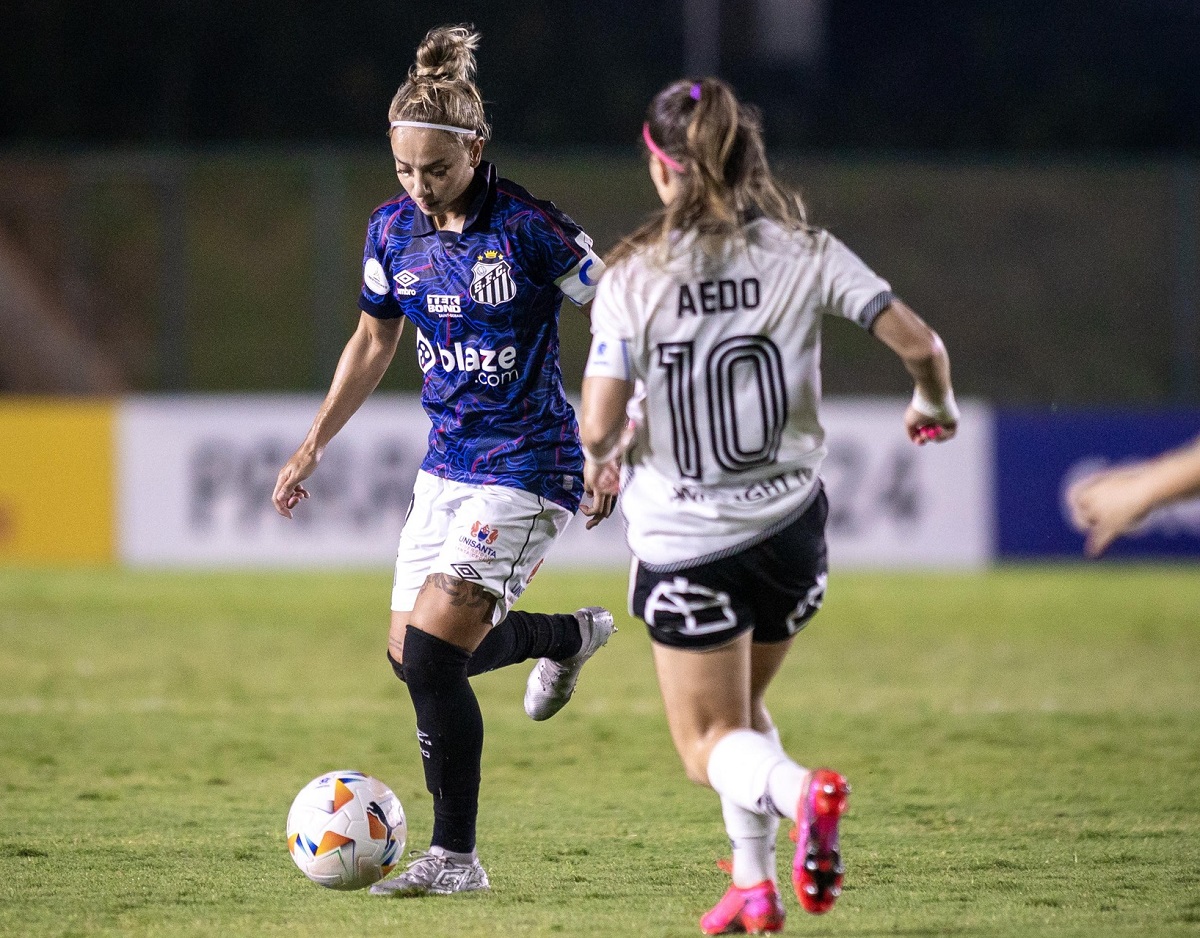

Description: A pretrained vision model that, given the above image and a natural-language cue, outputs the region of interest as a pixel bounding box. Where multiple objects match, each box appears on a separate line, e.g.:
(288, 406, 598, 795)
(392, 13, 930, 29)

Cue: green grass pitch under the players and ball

(0, 566, 1200, 938)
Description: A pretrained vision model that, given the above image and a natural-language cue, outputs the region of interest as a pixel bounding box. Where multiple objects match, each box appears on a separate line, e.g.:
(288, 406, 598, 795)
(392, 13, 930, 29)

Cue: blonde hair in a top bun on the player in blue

(388, 26, 492, 144)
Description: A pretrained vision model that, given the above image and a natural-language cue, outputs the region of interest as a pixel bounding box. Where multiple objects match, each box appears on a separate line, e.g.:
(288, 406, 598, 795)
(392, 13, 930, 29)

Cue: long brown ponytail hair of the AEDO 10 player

(607, 78, 805, 264)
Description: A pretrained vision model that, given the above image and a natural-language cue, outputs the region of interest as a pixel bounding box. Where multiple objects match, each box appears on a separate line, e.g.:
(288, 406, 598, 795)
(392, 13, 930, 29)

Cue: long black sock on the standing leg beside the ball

(404, 625, 484, 853)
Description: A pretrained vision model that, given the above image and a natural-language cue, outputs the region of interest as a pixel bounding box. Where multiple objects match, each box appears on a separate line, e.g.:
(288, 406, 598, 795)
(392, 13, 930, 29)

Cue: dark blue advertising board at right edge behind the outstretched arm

(996, 410, 1200, 559)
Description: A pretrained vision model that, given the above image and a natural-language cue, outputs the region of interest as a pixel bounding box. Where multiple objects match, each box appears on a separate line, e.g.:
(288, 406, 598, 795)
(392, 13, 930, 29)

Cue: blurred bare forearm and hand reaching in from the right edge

(1067, 438, 1200, 558)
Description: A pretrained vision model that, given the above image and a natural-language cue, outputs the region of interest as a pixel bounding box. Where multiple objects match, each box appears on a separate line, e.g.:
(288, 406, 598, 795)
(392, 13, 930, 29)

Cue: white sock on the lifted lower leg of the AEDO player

(708, 729, 808, 820)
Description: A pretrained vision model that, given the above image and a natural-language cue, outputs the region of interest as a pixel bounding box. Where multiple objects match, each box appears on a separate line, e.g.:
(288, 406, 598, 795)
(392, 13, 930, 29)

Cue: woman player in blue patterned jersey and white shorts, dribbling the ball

(274, 26, 614, 896)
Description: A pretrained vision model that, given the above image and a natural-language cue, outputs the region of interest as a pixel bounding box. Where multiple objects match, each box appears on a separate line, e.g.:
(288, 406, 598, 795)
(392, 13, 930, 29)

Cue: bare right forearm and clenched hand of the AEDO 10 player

(871, 299, 959, 445)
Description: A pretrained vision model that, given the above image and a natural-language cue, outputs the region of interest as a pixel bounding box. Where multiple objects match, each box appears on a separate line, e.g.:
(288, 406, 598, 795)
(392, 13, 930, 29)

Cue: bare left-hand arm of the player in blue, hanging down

(271, 313, 404, 518)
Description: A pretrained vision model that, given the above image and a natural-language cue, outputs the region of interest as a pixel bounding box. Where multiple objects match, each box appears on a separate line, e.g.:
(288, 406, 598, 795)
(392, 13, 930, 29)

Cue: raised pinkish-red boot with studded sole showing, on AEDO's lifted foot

(792, 769, 850, 915)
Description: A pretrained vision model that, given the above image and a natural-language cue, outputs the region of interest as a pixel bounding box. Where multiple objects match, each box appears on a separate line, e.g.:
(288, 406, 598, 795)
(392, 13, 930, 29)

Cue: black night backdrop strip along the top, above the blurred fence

(0, 0, 1200, 154)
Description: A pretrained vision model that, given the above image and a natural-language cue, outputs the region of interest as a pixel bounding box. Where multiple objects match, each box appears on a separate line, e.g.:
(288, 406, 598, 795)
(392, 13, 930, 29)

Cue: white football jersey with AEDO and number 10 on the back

(586, 218, 892, 570)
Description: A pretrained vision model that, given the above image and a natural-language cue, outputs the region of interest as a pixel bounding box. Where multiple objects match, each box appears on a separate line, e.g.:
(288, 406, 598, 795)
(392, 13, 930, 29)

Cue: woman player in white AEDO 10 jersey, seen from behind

(581, 78, 958, 934)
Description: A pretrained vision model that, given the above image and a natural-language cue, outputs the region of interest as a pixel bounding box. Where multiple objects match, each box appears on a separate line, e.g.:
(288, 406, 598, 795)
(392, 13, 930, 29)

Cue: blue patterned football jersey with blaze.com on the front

(359, 162, 604, 511)
